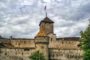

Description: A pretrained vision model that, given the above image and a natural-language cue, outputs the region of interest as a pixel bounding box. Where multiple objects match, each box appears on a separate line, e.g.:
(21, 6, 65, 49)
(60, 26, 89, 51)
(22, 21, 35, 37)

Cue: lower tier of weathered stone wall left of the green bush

(0, 48, 35, 60)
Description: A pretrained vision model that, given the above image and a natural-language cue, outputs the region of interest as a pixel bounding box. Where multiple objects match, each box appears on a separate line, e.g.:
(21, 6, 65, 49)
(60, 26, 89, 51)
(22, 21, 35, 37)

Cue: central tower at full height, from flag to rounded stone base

(35, 7, 54, 60)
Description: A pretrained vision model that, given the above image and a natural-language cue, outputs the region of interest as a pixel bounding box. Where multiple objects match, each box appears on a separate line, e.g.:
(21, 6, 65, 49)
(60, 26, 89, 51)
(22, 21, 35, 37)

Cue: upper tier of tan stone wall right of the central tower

(49, 40, 80, 49)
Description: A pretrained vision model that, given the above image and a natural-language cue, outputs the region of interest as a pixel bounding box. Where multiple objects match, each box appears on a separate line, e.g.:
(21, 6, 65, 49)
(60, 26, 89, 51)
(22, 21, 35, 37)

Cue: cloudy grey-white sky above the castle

(0, 0, 90, 38)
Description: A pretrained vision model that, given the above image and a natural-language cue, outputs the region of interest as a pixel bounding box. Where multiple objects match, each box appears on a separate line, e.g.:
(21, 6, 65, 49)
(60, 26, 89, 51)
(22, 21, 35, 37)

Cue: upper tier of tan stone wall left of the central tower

(10, 39, 35, 48)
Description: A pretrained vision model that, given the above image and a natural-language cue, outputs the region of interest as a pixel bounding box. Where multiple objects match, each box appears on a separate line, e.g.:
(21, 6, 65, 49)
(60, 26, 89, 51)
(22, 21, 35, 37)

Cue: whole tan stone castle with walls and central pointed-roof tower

(0, 17, 83, 60)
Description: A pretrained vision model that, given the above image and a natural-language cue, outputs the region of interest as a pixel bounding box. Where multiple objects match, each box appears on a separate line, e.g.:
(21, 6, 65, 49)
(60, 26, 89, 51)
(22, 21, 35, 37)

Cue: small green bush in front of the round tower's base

(29, 51, 45, 60)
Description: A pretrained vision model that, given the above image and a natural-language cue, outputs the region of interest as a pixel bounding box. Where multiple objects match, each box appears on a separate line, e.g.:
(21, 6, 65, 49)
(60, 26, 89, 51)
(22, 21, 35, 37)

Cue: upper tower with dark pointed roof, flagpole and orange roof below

(37, 6, 54, 36)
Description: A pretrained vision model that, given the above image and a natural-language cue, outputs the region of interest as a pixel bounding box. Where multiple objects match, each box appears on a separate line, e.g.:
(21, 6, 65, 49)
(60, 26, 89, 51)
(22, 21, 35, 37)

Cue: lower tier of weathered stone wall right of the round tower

(49, 49, 83, 60)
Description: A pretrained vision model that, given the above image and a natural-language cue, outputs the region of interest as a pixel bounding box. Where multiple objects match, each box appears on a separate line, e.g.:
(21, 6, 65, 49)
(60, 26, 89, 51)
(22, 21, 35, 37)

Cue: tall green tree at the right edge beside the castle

(80, 22, 90, 60)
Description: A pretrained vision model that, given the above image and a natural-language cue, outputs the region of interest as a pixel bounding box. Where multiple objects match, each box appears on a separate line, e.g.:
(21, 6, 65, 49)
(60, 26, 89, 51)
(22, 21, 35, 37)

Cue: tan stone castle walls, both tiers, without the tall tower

(0, 37, 83, 60)
